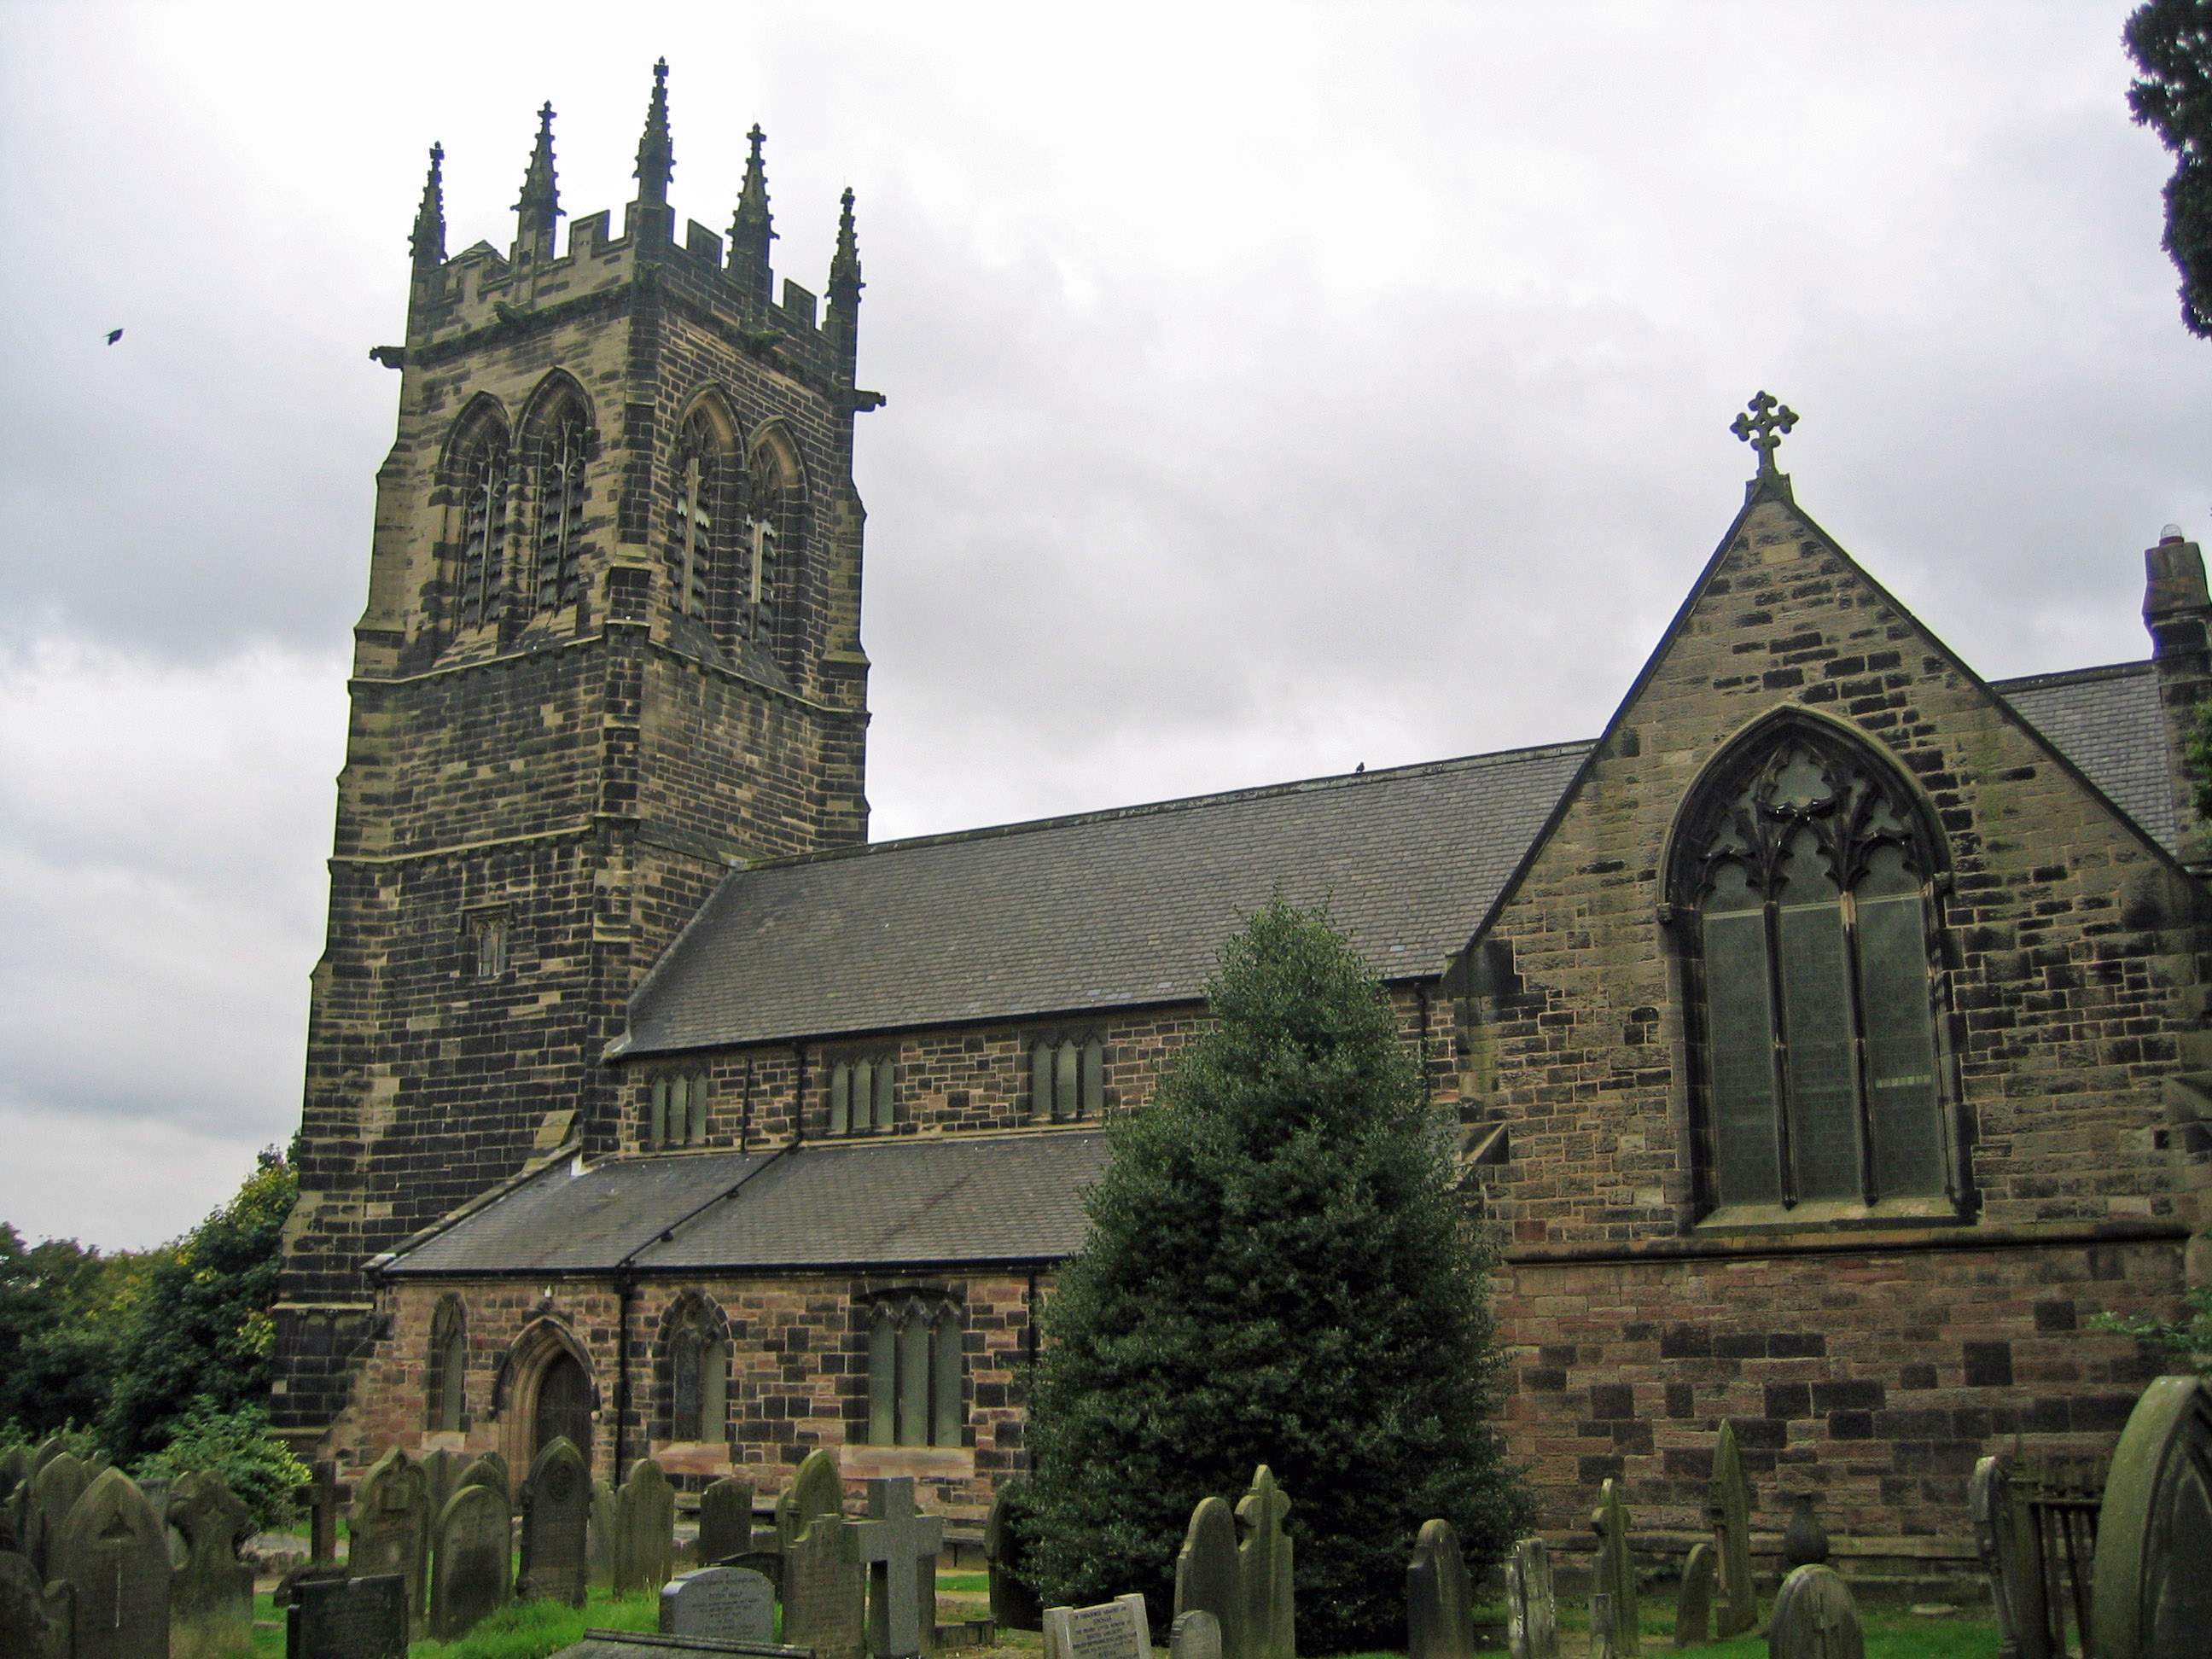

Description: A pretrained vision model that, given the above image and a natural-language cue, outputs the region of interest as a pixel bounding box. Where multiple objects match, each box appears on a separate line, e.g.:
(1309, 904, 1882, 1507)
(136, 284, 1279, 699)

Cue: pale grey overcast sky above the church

(0, 0, 2212, 1248)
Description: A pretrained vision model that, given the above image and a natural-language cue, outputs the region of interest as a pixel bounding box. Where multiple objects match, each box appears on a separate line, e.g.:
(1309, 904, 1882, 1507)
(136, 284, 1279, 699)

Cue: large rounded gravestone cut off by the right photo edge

(2086, 1376, 2212, 1659)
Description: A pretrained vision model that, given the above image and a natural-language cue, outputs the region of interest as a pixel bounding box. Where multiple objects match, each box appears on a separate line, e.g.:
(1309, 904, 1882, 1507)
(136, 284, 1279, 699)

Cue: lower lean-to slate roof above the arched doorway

(385, 1131, 1106, 1278)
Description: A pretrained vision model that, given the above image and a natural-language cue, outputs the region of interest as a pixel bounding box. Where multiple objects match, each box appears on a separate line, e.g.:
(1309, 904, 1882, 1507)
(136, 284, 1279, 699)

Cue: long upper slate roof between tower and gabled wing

(613, 743, 1591, 1055)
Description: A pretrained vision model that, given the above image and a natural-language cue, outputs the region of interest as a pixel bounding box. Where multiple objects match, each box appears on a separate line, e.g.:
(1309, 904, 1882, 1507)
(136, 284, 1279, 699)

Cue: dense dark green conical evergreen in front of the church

(1028, 900, 1528, 1652)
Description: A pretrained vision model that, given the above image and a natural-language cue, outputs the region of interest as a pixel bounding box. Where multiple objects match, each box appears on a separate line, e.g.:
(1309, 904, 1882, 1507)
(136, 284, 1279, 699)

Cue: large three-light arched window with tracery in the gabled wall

(1673, 719, 1953, 1206)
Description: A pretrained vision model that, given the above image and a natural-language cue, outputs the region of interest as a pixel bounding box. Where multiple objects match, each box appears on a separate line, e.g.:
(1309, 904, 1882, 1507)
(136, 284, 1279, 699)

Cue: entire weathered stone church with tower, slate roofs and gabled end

(276, 67, 2212, 1559)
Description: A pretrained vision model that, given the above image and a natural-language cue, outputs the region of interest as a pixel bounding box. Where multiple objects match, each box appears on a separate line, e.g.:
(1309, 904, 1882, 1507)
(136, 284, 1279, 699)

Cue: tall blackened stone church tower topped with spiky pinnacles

(276, 64, 882, 1438)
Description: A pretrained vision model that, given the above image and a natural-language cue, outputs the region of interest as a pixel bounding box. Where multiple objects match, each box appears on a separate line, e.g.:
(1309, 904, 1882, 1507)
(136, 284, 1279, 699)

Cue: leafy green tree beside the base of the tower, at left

(100, 1148, 299, 1462)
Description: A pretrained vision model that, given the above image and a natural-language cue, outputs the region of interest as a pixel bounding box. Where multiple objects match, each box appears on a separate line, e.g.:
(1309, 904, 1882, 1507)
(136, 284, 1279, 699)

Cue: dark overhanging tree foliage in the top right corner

(2123, 0, 2212, 336)
